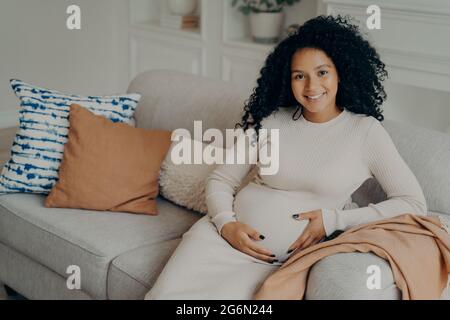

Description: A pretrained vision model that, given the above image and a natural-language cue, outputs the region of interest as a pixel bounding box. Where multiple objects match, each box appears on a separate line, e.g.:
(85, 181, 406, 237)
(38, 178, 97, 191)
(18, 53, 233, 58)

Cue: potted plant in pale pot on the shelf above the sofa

(232, 0, 301, 43)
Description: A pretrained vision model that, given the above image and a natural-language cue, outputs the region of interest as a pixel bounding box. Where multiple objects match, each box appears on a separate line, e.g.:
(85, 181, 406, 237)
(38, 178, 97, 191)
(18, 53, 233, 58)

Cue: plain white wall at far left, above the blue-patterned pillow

(0, 0, 128, 128)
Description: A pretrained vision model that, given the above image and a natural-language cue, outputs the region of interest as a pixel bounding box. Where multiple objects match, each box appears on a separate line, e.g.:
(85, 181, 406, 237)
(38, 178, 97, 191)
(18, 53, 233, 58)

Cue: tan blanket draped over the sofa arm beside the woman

(254, 213, 450, 300)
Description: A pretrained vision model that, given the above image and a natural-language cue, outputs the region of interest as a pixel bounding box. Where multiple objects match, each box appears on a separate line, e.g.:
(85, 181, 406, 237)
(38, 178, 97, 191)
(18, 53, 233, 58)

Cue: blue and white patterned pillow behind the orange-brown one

(0, 79, 141, 194)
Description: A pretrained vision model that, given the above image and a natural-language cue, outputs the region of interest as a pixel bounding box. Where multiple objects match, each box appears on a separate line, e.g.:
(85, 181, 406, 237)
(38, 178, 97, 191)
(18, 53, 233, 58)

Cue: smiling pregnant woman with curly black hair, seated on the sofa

(146, 16, 427, 299)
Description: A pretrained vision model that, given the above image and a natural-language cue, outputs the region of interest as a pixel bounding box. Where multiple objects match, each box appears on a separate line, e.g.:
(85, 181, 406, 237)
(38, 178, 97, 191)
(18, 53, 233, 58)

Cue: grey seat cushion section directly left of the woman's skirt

(108, 238, 181, 300)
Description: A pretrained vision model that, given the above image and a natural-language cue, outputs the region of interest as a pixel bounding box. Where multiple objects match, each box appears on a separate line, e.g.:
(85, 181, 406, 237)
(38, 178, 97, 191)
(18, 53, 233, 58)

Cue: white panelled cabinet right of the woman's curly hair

(323, 0, 450, 133)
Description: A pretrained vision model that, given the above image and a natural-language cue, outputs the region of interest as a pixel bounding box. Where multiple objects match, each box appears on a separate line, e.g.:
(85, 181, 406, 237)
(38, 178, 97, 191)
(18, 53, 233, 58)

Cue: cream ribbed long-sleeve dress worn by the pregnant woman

(146, 108, 427, 299)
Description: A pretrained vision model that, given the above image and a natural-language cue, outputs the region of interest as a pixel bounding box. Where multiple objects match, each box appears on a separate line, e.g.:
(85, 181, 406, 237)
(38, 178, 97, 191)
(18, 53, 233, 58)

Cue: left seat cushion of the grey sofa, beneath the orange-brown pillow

(0, 193, 201, 299)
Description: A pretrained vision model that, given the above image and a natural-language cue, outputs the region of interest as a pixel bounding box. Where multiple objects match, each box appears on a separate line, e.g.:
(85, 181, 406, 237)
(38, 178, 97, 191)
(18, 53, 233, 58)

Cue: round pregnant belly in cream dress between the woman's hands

(234, 183, 317, 262)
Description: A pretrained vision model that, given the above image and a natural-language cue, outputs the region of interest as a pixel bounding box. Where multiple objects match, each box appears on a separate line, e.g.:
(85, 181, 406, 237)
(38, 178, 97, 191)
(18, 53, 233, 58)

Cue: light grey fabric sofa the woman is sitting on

(0, 70, 450, 299)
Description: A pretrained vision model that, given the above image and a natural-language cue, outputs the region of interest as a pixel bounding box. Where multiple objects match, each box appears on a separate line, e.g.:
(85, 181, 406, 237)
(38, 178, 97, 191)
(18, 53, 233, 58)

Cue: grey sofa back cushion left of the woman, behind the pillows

(128, 70, 248, 140)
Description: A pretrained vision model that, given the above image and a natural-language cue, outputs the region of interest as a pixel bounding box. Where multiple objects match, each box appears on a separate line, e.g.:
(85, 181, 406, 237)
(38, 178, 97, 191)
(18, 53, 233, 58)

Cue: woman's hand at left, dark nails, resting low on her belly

(221, 221, 278, 263)
